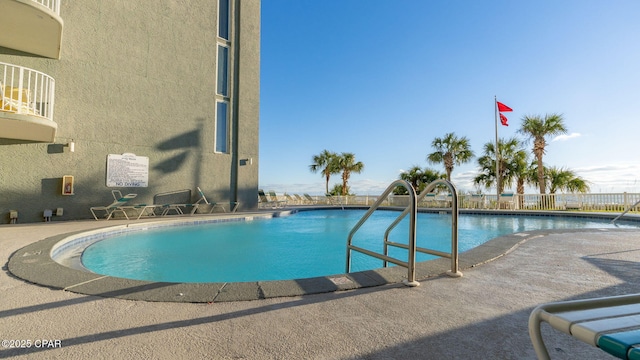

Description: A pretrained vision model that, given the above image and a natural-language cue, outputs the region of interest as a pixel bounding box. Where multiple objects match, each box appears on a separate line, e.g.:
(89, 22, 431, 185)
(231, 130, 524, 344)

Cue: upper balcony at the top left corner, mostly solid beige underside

(0, 0, 63, 59)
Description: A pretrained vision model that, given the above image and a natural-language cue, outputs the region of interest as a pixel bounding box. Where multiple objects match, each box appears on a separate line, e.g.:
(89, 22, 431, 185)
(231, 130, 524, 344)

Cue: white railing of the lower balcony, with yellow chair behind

(0, 62, 55, 121)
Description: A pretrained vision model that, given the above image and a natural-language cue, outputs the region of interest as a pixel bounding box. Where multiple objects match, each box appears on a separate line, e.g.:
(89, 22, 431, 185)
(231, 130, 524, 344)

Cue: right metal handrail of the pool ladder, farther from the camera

(384, 180, 462, 277)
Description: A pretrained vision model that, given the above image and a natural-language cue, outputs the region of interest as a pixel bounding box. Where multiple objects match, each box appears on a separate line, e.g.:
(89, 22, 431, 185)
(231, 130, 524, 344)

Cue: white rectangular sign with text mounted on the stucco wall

(107, 153, 149, 187)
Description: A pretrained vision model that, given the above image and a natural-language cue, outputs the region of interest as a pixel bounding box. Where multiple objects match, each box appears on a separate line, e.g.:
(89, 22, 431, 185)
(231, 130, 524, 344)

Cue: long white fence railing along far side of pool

(279, 193, 640, 213)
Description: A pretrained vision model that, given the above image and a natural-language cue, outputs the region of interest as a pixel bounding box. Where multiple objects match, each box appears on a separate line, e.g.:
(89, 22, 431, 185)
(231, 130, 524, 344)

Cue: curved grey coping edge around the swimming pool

(7, 212, 637, 303)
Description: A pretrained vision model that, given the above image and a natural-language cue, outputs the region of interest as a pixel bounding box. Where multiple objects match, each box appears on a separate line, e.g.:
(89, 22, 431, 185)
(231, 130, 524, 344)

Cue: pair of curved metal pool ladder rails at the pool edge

(346, 180, 462, 286)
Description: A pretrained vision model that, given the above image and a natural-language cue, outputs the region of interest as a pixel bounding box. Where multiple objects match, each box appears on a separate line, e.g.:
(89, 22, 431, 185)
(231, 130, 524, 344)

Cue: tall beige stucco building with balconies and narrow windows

(0, 0, 260, 223)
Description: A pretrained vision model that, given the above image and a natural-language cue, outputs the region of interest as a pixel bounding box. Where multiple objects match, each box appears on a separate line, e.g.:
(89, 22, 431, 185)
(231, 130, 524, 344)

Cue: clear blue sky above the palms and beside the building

(259, 0, 640, 195)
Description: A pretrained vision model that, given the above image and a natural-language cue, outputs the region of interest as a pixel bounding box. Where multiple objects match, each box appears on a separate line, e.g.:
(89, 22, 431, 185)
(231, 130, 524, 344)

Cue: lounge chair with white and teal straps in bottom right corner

(529, 294, 640, 360)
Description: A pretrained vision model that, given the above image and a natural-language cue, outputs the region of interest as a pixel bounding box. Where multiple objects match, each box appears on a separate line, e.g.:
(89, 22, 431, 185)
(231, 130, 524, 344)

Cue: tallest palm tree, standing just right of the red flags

(518, 114, 567, 194)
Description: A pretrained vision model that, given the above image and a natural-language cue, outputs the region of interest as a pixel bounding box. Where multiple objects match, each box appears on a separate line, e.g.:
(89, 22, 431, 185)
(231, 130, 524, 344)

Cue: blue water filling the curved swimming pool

(82, 210, 636, 282)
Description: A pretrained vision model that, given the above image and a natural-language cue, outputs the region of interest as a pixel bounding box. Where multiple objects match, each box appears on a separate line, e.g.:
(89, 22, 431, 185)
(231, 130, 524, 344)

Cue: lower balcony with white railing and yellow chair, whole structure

(0, 62, 58, 142)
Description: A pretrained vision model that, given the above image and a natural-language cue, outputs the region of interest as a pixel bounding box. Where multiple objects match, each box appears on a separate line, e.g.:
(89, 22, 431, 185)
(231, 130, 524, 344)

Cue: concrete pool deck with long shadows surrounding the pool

(0, 211, 640, 359)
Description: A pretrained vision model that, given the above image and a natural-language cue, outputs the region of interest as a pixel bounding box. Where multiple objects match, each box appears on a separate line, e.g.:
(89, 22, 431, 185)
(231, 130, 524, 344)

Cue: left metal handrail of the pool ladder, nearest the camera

(346, 180, 420, 286)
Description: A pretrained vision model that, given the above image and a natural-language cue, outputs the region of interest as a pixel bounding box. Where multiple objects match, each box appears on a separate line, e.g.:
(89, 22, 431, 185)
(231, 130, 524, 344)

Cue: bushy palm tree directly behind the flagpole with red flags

(473, 138, 527, 193)
